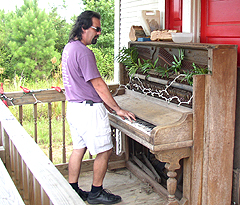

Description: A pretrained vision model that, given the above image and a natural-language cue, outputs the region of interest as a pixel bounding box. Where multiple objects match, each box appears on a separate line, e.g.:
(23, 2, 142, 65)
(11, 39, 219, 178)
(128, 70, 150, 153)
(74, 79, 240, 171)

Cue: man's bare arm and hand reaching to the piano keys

(91, 77, 136, 122)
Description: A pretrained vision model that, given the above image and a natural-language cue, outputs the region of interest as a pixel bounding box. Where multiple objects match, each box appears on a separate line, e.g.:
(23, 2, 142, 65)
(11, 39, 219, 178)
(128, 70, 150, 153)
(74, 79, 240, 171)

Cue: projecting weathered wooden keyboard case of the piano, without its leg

(109, 90, 193, 151)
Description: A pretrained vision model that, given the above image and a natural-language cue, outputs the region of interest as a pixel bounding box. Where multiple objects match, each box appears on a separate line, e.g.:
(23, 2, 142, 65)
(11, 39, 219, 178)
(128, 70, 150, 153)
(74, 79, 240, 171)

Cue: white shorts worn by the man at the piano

(67, 102, 113, 155)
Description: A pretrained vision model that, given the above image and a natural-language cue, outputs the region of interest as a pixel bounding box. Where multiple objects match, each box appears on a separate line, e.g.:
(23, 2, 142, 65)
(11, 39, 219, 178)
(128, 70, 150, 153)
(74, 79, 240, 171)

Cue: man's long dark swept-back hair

(68, 11, 101, 41)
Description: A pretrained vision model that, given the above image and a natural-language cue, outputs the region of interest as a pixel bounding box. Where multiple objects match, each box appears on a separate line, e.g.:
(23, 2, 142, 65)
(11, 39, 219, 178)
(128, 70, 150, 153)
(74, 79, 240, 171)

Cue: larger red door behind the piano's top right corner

(200, 0, 240, 66)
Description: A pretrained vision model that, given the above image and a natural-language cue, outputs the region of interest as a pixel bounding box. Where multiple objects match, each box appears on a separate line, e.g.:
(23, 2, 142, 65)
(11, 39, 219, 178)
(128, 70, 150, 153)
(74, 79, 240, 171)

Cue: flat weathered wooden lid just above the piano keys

(114, 90, 192, 126)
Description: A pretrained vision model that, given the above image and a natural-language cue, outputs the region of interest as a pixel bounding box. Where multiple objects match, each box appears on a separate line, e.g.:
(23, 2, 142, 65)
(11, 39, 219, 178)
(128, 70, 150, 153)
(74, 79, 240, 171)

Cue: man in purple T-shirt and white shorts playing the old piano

(62, 11, 135, 204)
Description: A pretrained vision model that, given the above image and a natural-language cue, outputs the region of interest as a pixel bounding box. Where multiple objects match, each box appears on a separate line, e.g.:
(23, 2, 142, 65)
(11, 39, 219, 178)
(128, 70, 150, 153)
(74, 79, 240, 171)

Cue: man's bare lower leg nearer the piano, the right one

(93, 149, 112, 186)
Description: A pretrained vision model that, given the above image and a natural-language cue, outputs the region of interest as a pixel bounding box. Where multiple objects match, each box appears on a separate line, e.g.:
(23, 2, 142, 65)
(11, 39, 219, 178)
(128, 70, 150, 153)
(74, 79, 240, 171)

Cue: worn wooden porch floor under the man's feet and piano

(68, 168, 167, 205)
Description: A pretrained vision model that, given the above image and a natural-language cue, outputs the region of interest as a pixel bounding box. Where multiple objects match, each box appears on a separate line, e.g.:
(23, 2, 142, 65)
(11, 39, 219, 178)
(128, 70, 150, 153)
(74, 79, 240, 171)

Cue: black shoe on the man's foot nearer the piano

(87, 189, 122, 204)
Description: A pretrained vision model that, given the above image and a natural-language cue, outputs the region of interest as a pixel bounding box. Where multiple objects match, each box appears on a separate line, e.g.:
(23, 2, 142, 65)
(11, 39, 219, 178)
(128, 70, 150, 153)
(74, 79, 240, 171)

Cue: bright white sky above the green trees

(0, 0, 82, 22)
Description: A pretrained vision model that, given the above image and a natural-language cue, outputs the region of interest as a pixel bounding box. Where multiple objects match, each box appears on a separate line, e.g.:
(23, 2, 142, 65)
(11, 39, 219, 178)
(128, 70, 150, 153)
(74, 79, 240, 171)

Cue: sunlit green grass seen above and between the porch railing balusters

(3, 78, 95, 164)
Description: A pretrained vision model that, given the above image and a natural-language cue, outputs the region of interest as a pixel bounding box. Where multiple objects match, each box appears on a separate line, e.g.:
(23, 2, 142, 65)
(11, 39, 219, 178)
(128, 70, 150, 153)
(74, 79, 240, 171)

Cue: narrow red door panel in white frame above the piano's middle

(165, 0, 182, 31)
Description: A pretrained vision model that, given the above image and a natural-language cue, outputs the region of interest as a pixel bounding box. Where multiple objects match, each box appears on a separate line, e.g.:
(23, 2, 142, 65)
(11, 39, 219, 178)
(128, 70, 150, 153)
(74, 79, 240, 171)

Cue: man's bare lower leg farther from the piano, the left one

(68, 147, 87, 183)
